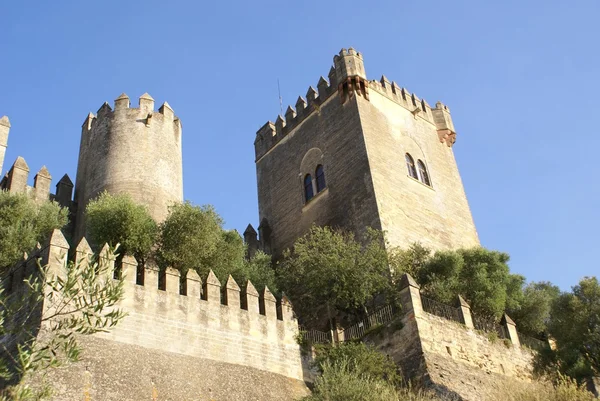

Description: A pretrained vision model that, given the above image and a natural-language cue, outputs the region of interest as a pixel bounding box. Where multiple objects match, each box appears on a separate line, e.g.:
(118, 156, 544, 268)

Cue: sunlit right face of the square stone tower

(358, 85, 479, 249)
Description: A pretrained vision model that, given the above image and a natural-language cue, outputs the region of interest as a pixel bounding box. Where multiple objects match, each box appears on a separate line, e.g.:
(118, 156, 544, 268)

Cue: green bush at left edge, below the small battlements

(0, 191, 68, 268)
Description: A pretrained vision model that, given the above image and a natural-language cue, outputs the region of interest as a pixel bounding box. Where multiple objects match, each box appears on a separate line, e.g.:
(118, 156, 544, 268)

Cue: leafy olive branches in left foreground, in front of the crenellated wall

(0, 245, 125, 400)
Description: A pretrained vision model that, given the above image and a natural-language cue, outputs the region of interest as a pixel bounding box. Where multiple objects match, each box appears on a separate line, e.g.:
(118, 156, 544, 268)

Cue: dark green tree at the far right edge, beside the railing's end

(548, 277, 600, 379)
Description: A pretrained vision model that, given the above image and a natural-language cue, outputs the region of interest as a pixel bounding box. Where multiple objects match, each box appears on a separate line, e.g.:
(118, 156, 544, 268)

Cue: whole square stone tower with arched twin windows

(254, 48, 479, 256)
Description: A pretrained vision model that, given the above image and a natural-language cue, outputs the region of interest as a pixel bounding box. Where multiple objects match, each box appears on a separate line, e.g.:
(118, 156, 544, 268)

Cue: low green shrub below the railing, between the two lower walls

(315, 342, 401, 385)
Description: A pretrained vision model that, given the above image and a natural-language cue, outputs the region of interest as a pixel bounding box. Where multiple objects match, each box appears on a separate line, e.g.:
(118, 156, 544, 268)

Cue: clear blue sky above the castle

(0, 0, 600, 290)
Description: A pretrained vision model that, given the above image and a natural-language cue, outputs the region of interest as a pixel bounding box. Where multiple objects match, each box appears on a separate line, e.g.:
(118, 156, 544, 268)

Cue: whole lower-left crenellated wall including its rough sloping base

(5, 230, 308, 401)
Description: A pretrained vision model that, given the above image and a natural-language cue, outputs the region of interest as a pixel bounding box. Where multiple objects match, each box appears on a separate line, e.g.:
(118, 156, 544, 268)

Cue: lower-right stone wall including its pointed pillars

(365, 275, 536, 401)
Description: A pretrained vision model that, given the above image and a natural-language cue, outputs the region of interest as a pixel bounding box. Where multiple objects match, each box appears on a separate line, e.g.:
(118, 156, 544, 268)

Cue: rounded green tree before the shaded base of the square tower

(277, 227, 389, 321)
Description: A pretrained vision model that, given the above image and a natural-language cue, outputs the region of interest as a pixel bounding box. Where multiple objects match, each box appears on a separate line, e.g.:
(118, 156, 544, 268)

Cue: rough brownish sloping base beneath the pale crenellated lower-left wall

(23, 337, 308, 401)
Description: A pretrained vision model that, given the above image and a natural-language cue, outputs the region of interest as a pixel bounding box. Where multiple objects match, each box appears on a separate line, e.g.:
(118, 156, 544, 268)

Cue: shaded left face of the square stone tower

(256, 91, 381, 255)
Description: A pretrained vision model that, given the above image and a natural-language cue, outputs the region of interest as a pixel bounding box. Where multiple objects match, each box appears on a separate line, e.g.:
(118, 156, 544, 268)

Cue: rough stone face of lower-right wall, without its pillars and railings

(368, 304, 533, 401)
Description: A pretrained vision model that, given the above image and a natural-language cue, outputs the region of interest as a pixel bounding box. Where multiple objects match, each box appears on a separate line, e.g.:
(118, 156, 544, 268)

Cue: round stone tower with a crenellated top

(74, 93, 183, 241)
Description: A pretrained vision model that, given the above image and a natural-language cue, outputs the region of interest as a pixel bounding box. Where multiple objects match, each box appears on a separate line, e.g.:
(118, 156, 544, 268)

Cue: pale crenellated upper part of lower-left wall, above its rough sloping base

(10, 230, 302, 379)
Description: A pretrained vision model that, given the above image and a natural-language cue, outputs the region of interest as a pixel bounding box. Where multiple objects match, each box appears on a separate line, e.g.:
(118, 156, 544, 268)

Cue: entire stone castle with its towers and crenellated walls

(0, 49, 564, 400)
